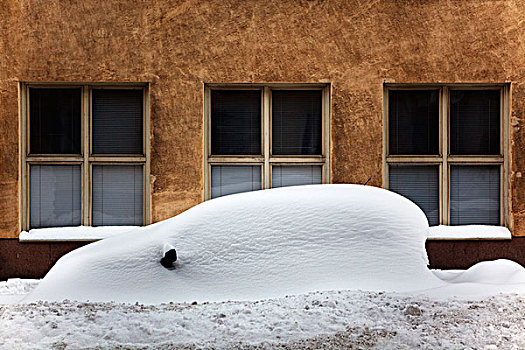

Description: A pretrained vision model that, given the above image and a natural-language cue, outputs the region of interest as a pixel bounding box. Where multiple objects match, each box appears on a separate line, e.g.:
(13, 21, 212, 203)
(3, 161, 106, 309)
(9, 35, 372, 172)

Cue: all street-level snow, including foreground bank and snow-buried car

(0, 185, 525, 350)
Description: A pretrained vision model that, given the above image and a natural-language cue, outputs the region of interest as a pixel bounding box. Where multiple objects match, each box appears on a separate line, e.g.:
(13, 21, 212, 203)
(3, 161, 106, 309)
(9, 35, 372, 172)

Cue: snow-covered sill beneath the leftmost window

(18, 226, 141, 242)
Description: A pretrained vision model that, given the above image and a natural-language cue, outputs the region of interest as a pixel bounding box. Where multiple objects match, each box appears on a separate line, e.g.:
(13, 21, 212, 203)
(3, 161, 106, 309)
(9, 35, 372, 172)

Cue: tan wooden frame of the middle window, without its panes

(203, 83, 331, 200)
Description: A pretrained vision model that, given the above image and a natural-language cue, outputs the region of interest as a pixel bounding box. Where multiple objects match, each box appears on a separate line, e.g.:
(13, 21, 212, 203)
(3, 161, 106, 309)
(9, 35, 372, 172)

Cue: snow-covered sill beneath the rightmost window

(427, 225, 512, 241)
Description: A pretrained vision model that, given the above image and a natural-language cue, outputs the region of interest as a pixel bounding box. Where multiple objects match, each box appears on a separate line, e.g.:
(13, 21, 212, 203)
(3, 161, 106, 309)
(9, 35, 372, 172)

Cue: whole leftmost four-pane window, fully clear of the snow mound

(22, 84, 149, 230)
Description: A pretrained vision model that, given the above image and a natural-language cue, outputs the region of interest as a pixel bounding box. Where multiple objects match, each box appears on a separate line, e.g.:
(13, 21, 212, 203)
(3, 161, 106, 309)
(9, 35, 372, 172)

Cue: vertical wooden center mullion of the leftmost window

(81, 86, 91, 226)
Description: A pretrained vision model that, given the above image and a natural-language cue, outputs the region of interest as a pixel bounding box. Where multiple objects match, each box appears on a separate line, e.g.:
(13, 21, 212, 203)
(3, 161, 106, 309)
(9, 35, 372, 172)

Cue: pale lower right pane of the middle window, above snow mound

(272, 165, 322, 187)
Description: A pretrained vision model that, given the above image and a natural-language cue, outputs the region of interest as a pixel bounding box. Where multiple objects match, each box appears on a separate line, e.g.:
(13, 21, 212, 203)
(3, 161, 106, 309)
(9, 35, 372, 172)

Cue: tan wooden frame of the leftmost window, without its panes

(19, 82, 151, 231)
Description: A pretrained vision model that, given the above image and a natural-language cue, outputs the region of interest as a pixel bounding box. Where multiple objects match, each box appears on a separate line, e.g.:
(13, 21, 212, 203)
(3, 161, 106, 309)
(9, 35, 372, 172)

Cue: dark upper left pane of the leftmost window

(29, 88, 81, 154)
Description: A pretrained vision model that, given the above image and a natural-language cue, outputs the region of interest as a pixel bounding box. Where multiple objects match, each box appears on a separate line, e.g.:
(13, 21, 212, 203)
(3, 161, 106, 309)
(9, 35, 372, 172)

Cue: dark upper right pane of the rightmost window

(450, 90, 500, 155)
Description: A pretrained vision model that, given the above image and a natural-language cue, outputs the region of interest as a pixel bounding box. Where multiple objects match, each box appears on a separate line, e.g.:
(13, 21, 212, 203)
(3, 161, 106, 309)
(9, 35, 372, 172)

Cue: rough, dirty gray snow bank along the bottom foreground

(0, 291, 525, 350)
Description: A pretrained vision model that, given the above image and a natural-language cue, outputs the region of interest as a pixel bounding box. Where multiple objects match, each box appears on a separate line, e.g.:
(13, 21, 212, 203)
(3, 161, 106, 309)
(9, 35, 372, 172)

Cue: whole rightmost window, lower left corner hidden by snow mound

(383, 85, 508, 226)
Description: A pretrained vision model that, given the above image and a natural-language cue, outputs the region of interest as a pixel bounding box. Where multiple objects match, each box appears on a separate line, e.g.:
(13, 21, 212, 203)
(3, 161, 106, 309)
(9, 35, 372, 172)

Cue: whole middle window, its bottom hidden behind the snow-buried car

(205, 84, 329, 199)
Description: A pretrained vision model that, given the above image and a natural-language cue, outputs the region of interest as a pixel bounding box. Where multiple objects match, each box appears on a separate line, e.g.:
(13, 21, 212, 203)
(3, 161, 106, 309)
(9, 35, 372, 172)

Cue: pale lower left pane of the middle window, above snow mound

(211, 165, 261, 198)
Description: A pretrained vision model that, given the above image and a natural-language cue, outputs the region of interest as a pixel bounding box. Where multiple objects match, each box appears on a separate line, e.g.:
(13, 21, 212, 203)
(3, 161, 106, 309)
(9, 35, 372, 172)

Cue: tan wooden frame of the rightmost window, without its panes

(382, 83, 510, 227)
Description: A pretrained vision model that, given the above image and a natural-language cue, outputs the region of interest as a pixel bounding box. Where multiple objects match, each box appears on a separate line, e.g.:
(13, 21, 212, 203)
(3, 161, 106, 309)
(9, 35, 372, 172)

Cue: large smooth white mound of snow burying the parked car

(24, 185, 445, 304)
